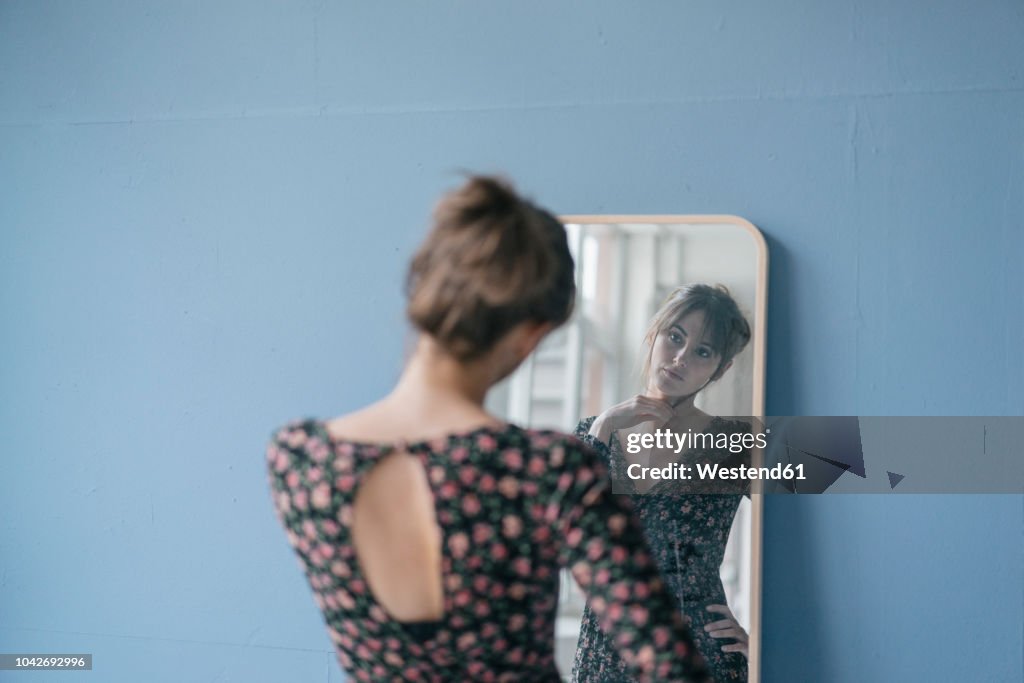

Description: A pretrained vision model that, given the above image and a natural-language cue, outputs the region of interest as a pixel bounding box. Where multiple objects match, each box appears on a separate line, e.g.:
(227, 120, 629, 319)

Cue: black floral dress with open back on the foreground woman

(266, 420, 707, 683)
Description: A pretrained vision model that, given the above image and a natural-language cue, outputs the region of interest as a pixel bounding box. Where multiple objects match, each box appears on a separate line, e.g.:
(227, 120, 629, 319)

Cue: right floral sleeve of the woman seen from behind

(557, 441, 710, 681)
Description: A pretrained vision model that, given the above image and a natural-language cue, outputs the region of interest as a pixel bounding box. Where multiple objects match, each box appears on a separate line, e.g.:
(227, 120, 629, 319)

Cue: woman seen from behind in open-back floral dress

(267, 177, 706, 682)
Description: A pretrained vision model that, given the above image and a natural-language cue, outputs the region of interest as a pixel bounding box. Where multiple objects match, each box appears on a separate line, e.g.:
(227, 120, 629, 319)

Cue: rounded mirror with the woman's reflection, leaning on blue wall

(488, 216, 767, 681)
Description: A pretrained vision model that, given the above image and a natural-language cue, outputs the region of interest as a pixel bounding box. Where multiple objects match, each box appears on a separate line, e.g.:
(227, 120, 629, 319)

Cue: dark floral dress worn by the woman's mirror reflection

(572, 417, 751, 683)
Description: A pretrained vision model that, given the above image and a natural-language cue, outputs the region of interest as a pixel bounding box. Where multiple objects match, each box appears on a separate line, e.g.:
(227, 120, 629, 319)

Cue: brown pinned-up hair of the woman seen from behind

(406, 175, 575, 360)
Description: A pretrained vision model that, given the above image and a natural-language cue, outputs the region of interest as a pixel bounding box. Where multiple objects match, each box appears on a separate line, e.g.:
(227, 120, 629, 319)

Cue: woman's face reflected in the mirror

(648, 310, 722, 396)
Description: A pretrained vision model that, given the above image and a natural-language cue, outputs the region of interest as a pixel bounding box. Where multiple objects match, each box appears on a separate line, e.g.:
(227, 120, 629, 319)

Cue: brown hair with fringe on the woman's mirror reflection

(641, 284, 751, 386)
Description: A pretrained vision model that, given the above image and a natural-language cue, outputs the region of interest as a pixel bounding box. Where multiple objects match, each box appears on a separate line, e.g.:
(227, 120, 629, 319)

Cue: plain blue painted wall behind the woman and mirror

(0, 0, 1024, 683)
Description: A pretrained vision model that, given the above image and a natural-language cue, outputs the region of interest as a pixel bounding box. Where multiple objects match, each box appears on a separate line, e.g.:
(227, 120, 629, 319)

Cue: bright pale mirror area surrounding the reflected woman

(488, 216, 768, 681)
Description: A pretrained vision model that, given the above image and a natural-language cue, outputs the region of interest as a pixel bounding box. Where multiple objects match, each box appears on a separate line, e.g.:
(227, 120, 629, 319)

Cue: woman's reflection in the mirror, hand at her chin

(572, 285, 751, 683)
